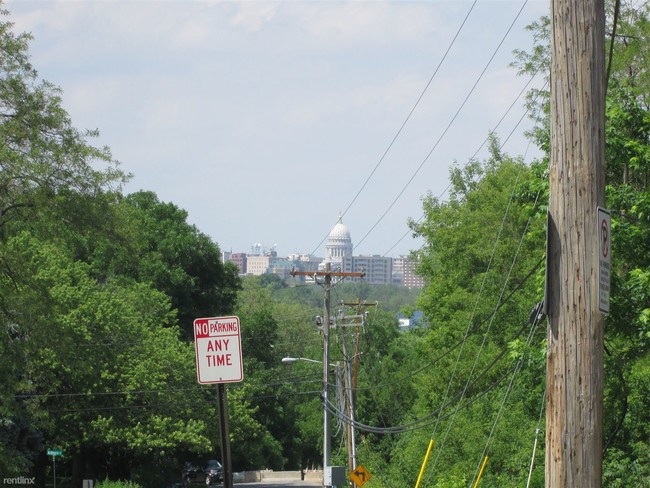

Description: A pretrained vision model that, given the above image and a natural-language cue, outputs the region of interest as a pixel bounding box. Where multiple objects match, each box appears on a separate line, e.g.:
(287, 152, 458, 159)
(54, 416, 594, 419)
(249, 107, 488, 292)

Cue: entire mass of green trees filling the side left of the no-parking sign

(0, 7, 240, 485)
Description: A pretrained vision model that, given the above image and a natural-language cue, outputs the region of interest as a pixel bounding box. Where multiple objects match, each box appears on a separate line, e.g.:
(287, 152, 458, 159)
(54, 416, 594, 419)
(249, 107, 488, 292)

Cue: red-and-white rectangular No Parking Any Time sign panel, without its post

(194, 316, 244, 384)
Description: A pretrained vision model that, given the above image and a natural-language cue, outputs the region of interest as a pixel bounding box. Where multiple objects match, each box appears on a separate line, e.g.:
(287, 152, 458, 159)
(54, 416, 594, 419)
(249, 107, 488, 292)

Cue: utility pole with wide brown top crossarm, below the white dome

(291, 261, 365, 486)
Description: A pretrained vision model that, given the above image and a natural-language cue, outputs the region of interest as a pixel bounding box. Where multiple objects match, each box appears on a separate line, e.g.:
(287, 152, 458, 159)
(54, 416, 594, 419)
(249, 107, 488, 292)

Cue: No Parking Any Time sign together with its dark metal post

(194, 316, 244, 488)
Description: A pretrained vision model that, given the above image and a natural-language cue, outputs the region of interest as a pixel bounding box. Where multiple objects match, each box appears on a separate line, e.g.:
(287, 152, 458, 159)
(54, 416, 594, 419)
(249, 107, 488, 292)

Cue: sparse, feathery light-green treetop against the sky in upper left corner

(0, 4, 127, 236)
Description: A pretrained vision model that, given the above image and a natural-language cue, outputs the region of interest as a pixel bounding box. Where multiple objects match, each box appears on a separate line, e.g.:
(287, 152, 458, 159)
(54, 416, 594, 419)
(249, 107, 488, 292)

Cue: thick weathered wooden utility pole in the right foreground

(546, 0, 605, 488)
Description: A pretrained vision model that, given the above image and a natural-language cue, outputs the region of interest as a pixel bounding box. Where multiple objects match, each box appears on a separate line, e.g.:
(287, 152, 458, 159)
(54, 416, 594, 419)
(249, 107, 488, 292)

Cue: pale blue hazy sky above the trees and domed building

(4, 0, 550, 257)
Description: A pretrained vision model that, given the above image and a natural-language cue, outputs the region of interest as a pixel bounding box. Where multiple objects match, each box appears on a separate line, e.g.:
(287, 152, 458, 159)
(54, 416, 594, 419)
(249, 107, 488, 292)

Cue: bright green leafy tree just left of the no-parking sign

(2, 234, 210, 482)
